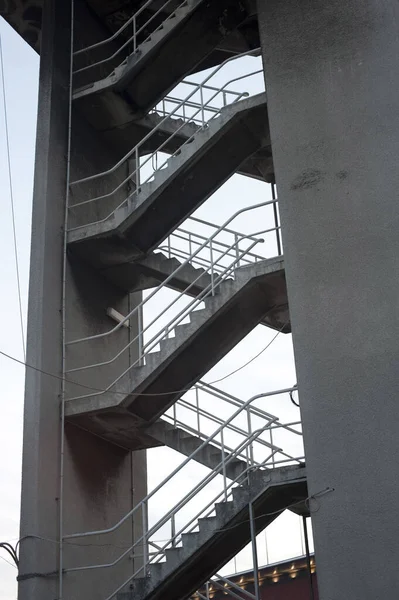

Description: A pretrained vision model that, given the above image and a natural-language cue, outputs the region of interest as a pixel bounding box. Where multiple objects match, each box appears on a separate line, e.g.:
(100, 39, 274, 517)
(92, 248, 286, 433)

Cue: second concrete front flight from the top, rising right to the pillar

(68, 94, 270, 255)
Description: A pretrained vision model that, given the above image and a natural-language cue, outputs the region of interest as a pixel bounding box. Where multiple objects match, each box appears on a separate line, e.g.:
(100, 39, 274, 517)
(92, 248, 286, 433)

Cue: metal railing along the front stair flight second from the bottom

(66, 200, 277, 400)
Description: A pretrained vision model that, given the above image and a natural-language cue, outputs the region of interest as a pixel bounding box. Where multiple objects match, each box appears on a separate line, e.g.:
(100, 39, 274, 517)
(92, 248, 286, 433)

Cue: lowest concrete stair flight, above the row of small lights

(117, 466, 308, 600)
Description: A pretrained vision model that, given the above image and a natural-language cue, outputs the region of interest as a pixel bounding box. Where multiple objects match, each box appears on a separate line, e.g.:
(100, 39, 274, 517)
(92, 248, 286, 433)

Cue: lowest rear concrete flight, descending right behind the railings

(145, 419, 252, 480)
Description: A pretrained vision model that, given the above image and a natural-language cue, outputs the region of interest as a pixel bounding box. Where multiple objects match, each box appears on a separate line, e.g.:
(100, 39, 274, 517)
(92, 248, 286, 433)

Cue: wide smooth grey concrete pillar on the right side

(258, 0, 399, 600)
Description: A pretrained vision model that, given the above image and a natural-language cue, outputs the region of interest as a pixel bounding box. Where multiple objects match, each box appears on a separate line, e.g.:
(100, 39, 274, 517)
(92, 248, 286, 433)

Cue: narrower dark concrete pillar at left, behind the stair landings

(19, 0, 146, 600)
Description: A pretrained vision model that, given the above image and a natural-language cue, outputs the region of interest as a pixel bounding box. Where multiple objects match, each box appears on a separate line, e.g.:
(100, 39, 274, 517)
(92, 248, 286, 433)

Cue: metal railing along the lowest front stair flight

(64, 388, 304, 600)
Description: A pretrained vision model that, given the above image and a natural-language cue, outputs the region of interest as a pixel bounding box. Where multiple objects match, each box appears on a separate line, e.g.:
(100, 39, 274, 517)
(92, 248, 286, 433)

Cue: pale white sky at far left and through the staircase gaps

(0, 19, 312, 600)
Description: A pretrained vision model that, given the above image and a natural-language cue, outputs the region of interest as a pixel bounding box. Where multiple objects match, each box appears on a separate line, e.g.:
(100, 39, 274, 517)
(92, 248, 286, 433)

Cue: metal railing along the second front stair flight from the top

(69, 50, 264, 231)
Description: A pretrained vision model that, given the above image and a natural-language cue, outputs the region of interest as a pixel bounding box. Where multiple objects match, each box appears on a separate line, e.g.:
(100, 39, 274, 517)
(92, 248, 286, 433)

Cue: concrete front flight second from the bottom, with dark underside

(66, 259, 289, 447)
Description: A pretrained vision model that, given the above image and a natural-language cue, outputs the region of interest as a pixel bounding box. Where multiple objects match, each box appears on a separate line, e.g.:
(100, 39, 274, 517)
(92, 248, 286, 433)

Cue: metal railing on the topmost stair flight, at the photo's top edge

(73, 0, 187, 75)
